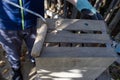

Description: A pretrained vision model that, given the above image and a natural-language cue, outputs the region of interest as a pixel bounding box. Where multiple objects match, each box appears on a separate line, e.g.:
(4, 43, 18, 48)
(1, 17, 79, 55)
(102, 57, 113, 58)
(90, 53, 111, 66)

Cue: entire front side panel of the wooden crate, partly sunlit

(36, 57, 114, 80)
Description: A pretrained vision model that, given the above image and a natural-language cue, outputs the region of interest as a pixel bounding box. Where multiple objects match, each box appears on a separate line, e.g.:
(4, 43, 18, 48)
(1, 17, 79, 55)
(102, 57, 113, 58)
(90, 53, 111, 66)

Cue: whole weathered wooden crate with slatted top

(36, 19, 115, 80)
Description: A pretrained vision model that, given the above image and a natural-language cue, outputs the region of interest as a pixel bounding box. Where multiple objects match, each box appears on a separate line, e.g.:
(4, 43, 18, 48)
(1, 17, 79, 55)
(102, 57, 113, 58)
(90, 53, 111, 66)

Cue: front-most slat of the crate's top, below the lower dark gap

(41, 47, 115, 58)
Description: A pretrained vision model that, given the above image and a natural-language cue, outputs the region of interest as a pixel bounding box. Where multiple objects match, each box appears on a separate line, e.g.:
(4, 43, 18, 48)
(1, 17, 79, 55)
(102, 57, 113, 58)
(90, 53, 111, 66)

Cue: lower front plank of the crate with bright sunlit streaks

(37, 67, 106, 80)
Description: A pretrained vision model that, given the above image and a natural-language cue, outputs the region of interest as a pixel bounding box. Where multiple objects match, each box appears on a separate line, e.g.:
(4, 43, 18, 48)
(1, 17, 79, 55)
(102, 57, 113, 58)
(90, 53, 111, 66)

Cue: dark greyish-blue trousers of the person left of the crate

(0, 27, 36, 69)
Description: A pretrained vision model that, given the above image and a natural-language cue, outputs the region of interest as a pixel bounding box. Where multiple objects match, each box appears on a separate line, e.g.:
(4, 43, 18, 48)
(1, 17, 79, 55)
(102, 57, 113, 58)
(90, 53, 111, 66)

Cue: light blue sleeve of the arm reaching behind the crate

(76, 0, 97, 14)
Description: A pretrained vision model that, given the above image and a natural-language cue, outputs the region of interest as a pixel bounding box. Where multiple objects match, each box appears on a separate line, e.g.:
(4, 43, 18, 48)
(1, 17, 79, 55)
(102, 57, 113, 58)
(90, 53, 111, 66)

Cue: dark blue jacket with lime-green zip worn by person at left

(0, 0, 44, 30)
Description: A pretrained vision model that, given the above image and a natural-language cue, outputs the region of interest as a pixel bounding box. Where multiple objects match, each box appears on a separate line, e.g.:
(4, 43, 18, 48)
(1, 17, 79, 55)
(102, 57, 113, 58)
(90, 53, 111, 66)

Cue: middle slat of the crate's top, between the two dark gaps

(45, 32, 111, 43)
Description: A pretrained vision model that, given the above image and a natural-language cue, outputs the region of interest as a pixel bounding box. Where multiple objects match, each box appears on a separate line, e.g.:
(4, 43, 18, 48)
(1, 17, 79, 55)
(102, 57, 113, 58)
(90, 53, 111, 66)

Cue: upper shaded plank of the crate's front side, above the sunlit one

(36, 57, 115, 70)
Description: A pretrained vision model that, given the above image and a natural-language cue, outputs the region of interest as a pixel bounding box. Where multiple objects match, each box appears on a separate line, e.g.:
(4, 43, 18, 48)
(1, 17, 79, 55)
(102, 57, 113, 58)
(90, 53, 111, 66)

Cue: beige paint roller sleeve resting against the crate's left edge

(31, 24, 47, 57)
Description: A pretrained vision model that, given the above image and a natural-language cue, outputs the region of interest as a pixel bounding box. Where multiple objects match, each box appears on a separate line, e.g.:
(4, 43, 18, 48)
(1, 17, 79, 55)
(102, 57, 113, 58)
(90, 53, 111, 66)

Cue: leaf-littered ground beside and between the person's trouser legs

(0, 47, 36, 80)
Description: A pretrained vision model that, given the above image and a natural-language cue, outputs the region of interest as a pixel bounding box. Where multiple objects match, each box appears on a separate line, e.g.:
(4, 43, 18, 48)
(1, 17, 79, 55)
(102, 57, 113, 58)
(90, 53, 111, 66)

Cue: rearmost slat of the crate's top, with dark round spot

(47, 19, 106, 33)
